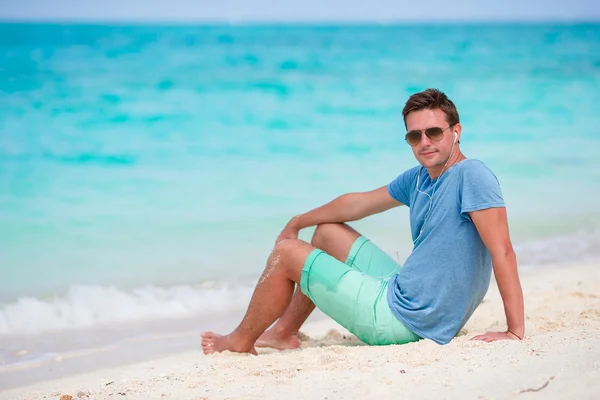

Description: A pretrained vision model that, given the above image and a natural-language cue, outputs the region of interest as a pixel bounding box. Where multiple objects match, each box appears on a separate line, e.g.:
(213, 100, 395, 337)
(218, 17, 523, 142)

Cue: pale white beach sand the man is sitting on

(0, 264, 600, 400)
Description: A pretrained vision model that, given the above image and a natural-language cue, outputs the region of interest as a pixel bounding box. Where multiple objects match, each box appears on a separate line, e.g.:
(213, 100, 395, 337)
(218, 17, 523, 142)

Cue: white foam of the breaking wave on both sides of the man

(0, 230, 600, 335)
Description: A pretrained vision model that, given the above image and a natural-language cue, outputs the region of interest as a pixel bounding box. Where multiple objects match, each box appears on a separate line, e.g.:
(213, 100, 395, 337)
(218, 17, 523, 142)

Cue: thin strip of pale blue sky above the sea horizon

(0, 0, 600, 22)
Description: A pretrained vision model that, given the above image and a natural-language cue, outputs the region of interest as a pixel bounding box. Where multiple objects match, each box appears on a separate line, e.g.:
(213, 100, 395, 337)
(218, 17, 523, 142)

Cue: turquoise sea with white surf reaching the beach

(0, 23, 600, 388)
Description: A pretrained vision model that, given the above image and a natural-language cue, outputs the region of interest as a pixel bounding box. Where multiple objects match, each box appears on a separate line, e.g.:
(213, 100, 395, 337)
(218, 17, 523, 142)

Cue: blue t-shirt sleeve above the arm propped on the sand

(460, 160, 505, 218)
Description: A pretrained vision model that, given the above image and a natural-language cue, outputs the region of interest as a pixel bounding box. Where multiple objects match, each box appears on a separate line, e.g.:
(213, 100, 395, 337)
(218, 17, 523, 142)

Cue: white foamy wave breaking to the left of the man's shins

(0, 284, 253, 335)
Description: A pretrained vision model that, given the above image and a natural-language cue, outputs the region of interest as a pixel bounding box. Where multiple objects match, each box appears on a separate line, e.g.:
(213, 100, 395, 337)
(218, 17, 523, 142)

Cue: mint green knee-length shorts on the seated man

(300, 236, 421, 345)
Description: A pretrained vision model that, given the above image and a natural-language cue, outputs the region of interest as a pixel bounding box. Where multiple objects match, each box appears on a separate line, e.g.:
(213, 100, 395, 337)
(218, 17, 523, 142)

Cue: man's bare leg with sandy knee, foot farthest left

(202, 239, 315, 354)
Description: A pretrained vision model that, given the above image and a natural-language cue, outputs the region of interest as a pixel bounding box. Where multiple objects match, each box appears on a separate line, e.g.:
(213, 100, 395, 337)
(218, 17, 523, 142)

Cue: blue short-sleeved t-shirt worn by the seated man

(387, 159, 504, 344)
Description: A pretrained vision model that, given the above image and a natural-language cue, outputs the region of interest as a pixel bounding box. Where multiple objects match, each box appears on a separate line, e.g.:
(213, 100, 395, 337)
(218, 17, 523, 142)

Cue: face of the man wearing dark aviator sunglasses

(406, 109, 460, 168)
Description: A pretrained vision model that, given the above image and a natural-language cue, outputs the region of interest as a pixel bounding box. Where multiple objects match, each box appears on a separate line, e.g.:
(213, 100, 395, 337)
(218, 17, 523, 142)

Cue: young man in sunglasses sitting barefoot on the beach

(202, 89, 525, 354)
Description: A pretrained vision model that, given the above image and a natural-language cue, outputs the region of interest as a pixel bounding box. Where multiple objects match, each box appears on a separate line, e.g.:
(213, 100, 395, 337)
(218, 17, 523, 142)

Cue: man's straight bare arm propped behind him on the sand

(469, 207, 525, 342)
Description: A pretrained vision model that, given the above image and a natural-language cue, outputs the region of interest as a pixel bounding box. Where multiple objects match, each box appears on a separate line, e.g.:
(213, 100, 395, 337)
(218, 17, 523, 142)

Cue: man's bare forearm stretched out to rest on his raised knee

(277, 186, 402, 242)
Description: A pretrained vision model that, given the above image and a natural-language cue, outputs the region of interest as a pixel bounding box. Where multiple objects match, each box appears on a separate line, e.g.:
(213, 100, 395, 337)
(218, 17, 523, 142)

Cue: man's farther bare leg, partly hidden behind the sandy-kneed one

(256, 224, 360, 350)
